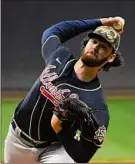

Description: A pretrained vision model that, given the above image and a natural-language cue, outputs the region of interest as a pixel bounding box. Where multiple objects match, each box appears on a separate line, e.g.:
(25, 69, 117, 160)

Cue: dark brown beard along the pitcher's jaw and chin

(81, 51, 108, 67)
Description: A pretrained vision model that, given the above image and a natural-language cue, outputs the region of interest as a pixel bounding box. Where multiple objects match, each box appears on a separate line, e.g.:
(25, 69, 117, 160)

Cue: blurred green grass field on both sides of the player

(2, 98, 135, 163)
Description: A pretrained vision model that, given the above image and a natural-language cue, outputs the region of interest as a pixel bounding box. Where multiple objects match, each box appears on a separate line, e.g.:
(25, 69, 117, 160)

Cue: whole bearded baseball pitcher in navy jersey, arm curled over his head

(4, 17, 124, 164)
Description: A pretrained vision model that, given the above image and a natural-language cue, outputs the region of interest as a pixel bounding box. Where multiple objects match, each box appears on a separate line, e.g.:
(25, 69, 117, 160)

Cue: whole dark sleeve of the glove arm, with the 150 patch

(57, 89, 109, 163)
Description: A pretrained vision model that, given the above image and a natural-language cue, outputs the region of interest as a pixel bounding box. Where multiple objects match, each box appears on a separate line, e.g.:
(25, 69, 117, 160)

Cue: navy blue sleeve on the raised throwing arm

(41, 19, 101, 63)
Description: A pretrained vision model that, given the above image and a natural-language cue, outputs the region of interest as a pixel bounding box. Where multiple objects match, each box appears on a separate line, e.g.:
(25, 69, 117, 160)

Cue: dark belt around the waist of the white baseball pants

(11, 120, 52, 148)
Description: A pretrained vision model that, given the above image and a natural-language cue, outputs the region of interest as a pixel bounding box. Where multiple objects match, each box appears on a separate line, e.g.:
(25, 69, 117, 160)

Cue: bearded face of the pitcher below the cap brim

(81, 38, 113, 67)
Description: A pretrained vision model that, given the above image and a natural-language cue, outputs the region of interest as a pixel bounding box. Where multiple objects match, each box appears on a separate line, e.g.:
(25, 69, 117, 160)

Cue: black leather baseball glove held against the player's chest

(54, 98, 92, 124)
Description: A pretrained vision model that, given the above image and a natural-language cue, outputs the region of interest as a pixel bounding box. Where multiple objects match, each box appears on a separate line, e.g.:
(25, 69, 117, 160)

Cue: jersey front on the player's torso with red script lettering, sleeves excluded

(15, 47, 108, 140)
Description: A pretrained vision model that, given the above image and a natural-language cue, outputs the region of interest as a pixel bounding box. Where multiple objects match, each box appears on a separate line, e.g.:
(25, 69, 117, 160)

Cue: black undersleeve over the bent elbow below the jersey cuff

(57, 129, 98, 163)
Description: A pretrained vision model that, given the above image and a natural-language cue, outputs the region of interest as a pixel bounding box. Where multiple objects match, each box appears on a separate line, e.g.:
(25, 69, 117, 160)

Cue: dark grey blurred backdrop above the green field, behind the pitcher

(1, 0, 135, 91)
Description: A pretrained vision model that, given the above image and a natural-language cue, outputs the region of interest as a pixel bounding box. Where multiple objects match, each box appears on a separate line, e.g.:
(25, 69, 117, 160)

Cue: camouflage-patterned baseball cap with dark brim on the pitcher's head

(88, 26, 120, 52)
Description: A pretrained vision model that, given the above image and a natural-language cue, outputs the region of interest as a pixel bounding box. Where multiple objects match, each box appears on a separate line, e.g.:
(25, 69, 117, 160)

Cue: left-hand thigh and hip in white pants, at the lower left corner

(4, 126, 37, 163)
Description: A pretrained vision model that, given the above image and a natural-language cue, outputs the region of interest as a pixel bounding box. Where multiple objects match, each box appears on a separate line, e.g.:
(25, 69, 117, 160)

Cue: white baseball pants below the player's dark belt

(4, 125, 74, 164)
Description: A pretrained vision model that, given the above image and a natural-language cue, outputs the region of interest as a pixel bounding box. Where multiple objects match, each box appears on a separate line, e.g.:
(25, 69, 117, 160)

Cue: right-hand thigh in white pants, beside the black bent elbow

(39, 143, 74, 163)
